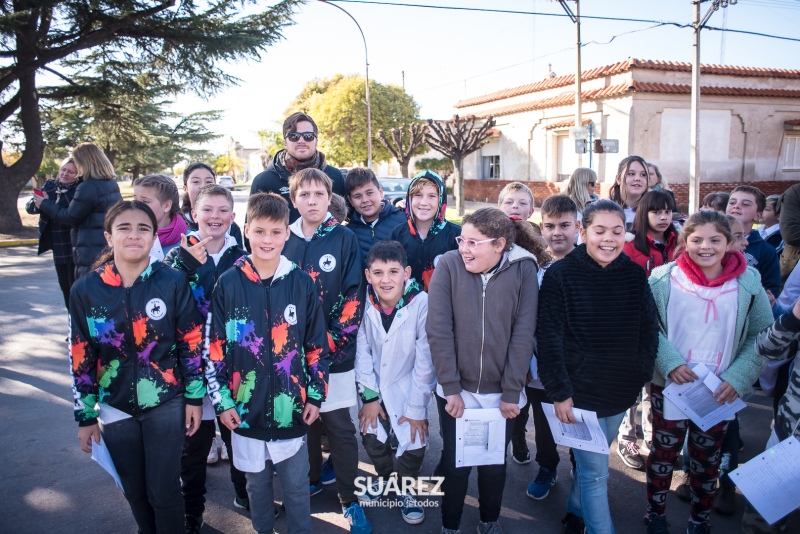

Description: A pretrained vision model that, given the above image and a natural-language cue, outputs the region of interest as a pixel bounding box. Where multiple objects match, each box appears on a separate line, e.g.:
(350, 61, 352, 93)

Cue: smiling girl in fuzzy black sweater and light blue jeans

(537, 200, 658, 534)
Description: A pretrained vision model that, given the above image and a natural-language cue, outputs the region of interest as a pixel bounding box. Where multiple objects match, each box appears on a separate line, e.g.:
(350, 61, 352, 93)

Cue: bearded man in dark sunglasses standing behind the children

(250, 111, 347, 223)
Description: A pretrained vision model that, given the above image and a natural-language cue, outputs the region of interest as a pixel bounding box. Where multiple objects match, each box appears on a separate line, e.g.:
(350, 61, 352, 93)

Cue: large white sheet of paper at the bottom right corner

(730, 437, 800, 525)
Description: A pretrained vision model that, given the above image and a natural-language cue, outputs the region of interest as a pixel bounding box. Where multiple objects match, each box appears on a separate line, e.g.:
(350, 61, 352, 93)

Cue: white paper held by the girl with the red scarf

(664, 363, 747, 430)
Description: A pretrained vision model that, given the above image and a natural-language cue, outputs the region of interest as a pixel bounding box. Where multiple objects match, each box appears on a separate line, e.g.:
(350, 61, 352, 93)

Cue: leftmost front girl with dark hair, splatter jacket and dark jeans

(69, 200, 206, 533)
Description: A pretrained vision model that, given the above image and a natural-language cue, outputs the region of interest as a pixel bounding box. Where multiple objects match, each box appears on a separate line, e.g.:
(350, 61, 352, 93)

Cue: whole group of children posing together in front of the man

(70, 161, 795, 534)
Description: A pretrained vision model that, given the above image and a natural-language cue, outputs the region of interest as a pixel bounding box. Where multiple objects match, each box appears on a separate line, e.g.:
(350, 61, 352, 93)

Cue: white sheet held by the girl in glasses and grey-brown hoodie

(456, 408, 506, 467)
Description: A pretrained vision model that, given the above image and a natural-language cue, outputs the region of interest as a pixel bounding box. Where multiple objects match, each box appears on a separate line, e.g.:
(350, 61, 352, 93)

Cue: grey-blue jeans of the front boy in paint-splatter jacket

(245, 440, 311, 534)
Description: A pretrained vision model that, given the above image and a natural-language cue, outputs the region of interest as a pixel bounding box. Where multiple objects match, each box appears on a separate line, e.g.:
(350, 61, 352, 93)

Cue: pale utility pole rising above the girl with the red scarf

(689, 0, 737, 214)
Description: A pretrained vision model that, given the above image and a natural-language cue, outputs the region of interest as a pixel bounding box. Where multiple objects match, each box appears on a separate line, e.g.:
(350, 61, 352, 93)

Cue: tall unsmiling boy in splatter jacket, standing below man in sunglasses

(284, 169, 372, 534)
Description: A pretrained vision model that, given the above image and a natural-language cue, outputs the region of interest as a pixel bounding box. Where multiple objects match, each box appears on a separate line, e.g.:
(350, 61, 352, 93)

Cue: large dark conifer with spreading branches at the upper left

(0, 0, 301, 232)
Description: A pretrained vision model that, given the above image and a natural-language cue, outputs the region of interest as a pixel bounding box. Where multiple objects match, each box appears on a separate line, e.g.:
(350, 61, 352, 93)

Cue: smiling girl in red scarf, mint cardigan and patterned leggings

(645, 211, 772, 534)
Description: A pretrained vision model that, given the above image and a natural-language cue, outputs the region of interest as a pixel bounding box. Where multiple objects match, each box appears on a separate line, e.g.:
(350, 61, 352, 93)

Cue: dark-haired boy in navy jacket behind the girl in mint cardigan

(726, 185, 781, 295)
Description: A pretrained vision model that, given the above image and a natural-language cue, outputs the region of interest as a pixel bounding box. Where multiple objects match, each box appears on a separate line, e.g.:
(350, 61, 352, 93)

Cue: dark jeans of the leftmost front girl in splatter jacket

(100, 396, 186, 534)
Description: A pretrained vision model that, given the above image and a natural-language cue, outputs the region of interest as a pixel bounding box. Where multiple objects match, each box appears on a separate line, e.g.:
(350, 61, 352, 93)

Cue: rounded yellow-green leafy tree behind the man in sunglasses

(287, 74, 419, 165)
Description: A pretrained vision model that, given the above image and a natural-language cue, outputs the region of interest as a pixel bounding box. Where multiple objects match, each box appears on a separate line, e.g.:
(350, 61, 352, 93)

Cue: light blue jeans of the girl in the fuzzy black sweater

(567, 412, 625, 534)
